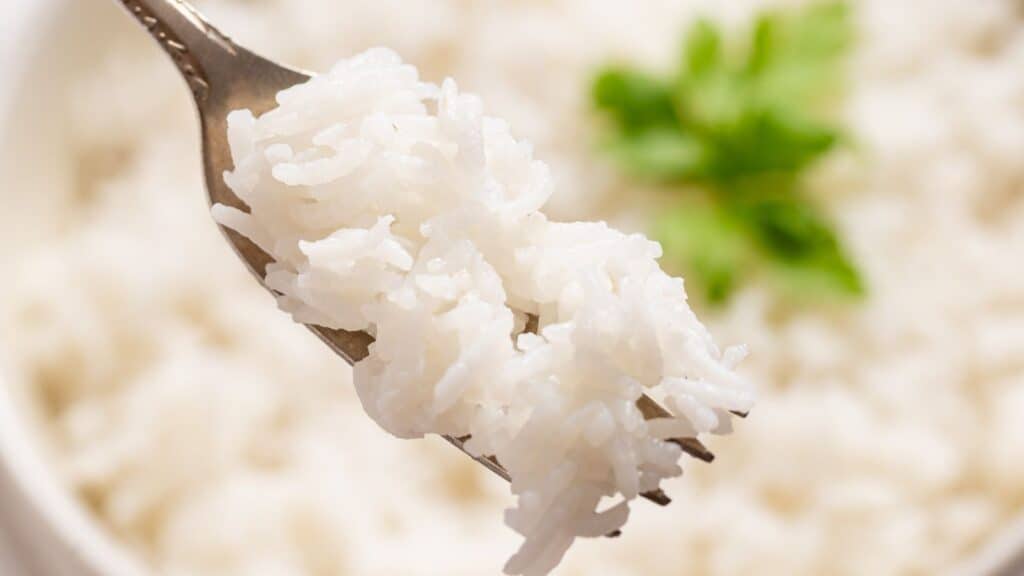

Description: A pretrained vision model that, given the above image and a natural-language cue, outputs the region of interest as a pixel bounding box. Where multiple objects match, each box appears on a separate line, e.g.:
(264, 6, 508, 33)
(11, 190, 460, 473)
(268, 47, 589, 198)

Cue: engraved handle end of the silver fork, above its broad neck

(120, 0, 239, 102)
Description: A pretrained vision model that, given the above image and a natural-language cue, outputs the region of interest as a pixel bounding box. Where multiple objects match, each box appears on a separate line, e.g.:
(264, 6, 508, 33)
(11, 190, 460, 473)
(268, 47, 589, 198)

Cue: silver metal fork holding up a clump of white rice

(119, 0, 742, 510)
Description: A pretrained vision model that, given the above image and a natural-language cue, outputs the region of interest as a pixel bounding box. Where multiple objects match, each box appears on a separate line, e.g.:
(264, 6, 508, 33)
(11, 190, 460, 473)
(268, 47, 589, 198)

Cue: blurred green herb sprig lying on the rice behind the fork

(593, 2, 863, 302)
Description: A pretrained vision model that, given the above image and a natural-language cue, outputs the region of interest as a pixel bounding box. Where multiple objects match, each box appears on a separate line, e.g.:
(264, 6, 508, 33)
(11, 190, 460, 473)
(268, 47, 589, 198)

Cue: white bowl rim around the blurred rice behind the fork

(0, 0, 1024, 576)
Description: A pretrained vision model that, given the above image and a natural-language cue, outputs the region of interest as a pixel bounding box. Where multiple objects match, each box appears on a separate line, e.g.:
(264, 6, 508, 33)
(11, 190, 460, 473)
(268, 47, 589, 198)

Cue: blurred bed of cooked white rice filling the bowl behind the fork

(0, 0, 1024, 576)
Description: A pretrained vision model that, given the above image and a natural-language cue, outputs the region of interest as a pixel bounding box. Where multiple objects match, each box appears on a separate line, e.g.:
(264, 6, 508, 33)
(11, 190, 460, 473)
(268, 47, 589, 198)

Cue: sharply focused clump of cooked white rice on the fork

(214, 49, 753, 575)
